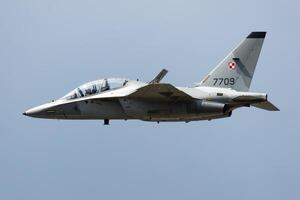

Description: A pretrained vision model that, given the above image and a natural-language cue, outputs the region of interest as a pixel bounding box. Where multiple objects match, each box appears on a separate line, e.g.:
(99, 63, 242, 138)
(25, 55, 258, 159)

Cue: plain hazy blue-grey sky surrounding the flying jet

(0, 0, 300, 200)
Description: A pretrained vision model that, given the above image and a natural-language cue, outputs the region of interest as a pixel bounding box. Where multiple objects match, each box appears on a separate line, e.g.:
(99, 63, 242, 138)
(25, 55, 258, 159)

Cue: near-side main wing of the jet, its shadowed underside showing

(128, 83, 194, 101)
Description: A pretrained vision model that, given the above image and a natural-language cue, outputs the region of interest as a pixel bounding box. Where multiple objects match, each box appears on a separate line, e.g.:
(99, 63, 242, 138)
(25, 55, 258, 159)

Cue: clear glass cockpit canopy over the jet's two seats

(61, 78, 128, 100)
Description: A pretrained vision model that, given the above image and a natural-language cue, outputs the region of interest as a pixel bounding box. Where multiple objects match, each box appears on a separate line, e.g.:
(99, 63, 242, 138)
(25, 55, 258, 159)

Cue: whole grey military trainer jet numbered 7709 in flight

(23, 32, 279, 125)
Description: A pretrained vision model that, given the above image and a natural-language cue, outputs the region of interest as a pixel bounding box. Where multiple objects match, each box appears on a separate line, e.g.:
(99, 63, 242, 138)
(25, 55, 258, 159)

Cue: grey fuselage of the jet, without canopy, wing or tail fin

(24, 80, 266, 121)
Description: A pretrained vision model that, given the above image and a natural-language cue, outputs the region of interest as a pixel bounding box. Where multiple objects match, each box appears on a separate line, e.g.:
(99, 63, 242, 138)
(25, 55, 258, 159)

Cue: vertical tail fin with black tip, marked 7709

(200, 32, 266, 91)
